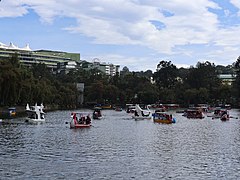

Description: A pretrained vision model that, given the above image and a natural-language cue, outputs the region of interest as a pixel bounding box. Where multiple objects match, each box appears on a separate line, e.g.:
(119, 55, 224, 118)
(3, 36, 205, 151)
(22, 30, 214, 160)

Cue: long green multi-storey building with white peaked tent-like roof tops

(0, 43, 80, 71)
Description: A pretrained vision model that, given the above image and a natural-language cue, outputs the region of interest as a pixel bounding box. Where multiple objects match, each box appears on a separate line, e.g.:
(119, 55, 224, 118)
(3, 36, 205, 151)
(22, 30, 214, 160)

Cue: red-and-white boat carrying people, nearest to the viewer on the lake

(70, 112, 91, 128)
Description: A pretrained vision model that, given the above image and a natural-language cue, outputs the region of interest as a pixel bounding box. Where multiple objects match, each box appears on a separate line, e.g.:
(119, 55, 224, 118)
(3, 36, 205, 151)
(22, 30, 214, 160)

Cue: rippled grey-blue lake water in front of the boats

(0, 110, 240, 180)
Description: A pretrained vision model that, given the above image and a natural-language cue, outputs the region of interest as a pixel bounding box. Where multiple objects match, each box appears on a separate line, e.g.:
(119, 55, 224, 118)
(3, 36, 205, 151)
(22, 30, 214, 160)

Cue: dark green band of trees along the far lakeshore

(0, 54, 240, 108)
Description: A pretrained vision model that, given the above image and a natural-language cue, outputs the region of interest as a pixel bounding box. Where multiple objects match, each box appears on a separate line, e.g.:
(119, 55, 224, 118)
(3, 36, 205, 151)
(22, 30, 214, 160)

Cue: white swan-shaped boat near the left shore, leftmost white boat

(26, 103, 45, 123)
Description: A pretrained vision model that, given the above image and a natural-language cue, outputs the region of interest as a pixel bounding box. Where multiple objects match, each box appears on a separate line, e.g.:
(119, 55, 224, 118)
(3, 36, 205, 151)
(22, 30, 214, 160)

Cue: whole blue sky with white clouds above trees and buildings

(0, 0, 240, 71)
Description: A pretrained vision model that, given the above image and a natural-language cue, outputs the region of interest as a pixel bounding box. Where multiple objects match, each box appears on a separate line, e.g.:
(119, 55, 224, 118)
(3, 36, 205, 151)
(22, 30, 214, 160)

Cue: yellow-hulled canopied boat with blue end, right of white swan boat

(153, 111, 176, 124)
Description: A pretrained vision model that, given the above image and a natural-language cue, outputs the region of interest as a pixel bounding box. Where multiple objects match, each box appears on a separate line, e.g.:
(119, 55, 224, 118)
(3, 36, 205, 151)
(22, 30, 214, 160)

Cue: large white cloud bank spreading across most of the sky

(0, 0, 240, 66)
